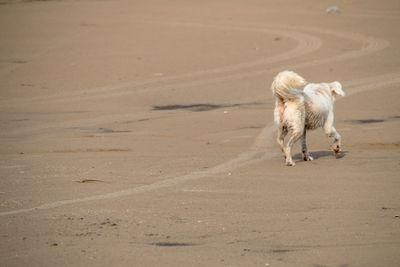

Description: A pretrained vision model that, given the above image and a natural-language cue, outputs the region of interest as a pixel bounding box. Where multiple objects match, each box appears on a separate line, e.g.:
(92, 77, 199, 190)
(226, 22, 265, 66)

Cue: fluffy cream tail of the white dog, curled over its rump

(271, 70, 307, 100)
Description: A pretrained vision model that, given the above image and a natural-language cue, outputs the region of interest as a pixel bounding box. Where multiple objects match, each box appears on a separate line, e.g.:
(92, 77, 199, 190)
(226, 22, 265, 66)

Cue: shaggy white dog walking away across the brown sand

(271, 70, 345, 166)
